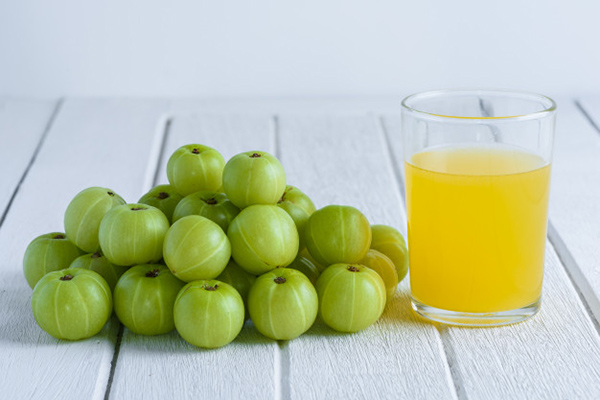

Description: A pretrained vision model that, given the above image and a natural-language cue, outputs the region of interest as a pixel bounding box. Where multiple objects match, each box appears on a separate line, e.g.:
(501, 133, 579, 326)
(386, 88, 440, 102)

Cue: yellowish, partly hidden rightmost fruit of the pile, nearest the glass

(371, 225, 408, 282)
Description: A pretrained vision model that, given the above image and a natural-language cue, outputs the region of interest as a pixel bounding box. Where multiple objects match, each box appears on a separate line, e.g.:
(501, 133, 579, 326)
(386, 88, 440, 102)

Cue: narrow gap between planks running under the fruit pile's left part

(104, 115, 173, 400)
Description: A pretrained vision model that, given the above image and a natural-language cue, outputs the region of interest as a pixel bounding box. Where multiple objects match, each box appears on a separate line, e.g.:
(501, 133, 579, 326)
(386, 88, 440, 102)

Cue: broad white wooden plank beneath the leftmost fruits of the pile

(0, 100, 166, 399)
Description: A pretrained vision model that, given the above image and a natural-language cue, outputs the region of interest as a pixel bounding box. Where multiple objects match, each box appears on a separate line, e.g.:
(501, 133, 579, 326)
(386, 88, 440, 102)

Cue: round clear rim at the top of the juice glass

(402, 88, 557, 122)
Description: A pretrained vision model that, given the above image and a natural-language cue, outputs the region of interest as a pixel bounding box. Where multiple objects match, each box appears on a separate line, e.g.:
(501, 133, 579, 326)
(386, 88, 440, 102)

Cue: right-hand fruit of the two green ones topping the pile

(223, 151, 285, 209)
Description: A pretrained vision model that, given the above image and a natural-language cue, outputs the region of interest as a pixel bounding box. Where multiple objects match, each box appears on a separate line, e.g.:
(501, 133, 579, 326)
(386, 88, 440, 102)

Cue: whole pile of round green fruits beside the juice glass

(23, 144, 407, 348)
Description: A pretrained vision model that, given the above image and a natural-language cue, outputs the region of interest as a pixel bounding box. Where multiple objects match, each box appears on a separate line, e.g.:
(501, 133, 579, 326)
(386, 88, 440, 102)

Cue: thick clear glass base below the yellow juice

(411, 298, 542, 327)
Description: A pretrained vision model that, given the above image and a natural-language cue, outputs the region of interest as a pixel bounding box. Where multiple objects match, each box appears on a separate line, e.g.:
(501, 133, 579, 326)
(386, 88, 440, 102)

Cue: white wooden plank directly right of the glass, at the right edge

(549, 97, 600, 320)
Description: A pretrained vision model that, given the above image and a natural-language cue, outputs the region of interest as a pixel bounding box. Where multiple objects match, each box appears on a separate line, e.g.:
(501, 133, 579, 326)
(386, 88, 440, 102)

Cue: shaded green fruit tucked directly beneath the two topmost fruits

(173, 190, 240, 232)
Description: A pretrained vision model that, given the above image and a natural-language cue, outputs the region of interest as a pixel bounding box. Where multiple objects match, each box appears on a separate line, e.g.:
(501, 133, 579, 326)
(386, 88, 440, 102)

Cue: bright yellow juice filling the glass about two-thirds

(405, 144, 550, 313)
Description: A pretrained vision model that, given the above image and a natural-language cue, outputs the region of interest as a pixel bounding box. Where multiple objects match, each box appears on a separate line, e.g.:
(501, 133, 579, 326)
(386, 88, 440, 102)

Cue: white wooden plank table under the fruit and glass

(0, 96, 600, 399)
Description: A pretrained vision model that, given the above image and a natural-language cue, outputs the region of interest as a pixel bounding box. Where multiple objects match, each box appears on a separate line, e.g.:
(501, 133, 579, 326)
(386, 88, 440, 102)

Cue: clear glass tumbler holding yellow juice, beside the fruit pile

(402, 90, 556, 326)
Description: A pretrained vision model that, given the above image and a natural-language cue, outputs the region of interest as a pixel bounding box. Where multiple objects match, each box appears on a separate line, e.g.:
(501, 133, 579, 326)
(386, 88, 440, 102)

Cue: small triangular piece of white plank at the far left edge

(0, 99, 57, 219)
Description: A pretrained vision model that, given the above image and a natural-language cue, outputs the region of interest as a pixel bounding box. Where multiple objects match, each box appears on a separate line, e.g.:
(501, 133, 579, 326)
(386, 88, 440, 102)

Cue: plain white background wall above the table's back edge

(0, 0, 600, 97)
